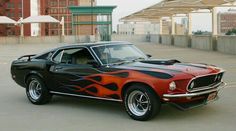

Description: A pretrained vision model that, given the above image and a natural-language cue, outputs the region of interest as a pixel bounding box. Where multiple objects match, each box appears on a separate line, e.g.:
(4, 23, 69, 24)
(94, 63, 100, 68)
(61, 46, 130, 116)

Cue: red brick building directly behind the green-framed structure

(39, 0, 96, 36)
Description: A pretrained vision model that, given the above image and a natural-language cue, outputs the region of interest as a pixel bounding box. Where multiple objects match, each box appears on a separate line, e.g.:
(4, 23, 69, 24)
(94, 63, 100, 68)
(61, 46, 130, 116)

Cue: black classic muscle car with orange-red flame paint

(11, 42, 226, 121)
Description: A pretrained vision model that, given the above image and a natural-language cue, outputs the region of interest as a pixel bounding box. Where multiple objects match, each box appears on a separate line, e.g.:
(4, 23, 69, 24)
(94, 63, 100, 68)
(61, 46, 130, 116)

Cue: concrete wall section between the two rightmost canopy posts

(191, 35, 213, 50)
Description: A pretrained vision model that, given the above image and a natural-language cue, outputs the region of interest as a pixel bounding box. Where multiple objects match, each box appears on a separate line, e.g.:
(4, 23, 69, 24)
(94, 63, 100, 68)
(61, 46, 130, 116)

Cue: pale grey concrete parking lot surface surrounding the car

(0, 43, 236, 131)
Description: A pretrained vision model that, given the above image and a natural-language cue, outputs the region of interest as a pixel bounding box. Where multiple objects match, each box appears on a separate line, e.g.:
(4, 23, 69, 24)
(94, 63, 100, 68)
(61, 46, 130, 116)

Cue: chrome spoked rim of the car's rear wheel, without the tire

(29, 79, 42, 100)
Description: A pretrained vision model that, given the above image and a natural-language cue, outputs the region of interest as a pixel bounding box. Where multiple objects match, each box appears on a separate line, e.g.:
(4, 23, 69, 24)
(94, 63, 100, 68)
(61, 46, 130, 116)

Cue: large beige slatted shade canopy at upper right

(121, 0, 236, 21)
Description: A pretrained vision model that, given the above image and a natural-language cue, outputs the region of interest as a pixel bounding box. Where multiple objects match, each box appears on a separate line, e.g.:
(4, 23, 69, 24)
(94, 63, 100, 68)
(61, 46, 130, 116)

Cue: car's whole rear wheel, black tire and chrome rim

(26, 76, 52, 105)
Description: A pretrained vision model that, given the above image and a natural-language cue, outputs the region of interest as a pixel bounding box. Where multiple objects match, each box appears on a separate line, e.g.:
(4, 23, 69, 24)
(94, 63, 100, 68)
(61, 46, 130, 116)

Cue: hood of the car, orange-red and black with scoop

(114, 60, 219, 76)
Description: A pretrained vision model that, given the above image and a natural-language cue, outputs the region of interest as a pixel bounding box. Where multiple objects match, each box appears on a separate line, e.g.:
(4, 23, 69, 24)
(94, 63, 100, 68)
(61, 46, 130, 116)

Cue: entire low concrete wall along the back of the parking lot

(0, 35, 236, 55)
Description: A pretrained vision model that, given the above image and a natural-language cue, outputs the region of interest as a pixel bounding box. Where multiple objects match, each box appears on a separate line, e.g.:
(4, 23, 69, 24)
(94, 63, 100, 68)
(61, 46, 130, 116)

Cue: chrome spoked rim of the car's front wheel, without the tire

(128, 90, 150, 116)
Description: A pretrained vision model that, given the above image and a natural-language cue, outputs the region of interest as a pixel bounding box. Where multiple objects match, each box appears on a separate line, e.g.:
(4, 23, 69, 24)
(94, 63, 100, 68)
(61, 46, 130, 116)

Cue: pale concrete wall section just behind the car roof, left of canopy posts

(111, 34, 147, 42)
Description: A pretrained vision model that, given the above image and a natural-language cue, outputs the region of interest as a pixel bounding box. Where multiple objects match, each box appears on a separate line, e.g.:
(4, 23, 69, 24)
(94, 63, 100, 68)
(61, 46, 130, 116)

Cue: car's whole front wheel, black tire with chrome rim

(124, 84, 161, 121)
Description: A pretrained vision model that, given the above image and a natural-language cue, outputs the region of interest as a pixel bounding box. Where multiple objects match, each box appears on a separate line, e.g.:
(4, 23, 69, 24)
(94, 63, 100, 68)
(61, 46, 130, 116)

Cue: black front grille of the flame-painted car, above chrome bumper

(188, 73, 224, 91)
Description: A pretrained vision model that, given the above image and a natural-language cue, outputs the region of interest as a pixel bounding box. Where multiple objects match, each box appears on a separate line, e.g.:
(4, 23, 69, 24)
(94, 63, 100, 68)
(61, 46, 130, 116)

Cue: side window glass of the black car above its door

(53, 48, 94, 65)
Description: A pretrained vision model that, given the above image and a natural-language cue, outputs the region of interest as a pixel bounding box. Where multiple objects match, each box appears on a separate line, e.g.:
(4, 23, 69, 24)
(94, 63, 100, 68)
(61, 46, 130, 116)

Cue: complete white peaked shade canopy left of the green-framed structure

(20, 15, 60, 24)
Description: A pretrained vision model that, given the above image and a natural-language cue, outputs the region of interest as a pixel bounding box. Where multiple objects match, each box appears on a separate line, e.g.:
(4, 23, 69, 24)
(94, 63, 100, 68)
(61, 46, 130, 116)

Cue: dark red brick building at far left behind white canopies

(0, 0, 31, 36)
